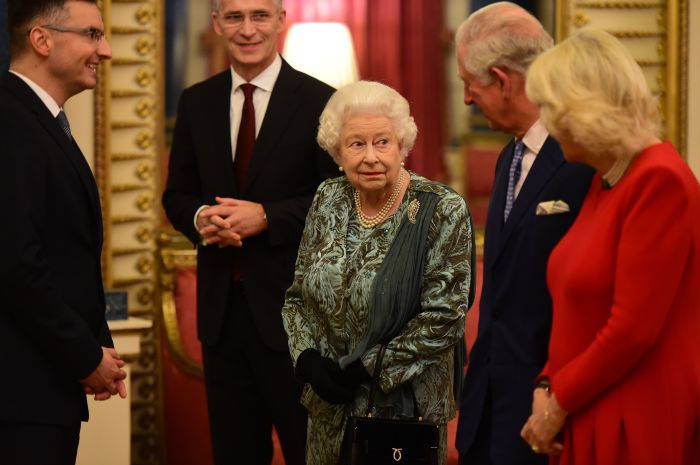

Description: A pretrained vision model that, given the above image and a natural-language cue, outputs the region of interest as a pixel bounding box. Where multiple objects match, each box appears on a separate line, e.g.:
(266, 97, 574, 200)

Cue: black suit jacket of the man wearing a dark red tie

(163, 61, 338, 351)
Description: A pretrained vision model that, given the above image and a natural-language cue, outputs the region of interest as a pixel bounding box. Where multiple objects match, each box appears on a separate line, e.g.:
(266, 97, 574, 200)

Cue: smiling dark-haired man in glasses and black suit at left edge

(0, 0, 126, 465)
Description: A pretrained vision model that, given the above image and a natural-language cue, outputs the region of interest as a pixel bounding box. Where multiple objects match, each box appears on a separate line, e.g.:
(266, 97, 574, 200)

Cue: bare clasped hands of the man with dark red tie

(197, 197, 267, 247)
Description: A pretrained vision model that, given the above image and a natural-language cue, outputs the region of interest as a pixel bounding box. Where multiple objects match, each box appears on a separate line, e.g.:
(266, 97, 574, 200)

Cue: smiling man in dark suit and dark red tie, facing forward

(163, 0, 337, 465)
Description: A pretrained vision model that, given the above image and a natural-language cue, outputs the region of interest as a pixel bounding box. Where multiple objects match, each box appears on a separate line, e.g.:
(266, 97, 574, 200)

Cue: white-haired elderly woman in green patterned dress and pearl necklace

(282, 81, 472, 465)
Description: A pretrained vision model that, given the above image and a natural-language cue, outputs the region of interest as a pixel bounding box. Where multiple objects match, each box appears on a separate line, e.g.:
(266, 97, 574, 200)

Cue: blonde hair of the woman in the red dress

(525, 28, 659, 159)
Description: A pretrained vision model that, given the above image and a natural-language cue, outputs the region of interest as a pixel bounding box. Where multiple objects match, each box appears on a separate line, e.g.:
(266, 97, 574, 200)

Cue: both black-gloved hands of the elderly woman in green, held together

(295, 348, 372, 404)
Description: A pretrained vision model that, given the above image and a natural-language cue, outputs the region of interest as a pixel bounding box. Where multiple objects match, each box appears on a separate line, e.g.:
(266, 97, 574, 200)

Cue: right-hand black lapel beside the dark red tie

(243, 60, 300, 192)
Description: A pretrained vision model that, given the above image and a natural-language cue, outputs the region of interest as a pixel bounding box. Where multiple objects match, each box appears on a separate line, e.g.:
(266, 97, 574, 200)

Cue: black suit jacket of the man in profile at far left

(0, 73, 112, 424)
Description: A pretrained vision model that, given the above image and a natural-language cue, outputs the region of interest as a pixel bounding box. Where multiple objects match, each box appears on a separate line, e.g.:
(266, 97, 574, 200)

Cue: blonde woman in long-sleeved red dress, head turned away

(521, 29, 700, 465)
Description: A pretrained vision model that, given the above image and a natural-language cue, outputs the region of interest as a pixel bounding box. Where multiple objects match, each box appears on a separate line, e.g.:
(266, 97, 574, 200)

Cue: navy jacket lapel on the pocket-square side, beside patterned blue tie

(497, 137, 564, 260)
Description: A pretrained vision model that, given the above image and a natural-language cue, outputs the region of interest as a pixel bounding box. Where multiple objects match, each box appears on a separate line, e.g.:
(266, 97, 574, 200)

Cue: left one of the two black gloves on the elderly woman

(295, 348, 353, 404)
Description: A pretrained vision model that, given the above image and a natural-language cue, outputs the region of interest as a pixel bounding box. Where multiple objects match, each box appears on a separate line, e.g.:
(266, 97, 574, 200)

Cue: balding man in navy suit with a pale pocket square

(456, 2, 592, 465)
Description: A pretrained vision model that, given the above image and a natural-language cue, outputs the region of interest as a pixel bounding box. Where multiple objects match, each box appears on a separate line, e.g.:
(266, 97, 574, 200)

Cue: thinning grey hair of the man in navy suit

(455, 2, 554, 85)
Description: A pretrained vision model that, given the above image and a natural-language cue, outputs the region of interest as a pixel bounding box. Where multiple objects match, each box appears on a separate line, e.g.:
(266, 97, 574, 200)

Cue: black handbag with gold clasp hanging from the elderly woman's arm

(340, 345, 440, 465)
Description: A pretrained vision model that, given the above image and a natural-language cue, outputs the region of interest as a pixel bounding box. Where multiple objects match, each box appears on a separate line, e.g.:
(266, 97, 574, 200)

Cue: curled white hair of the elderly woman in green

(316, 81, 418, 164)
